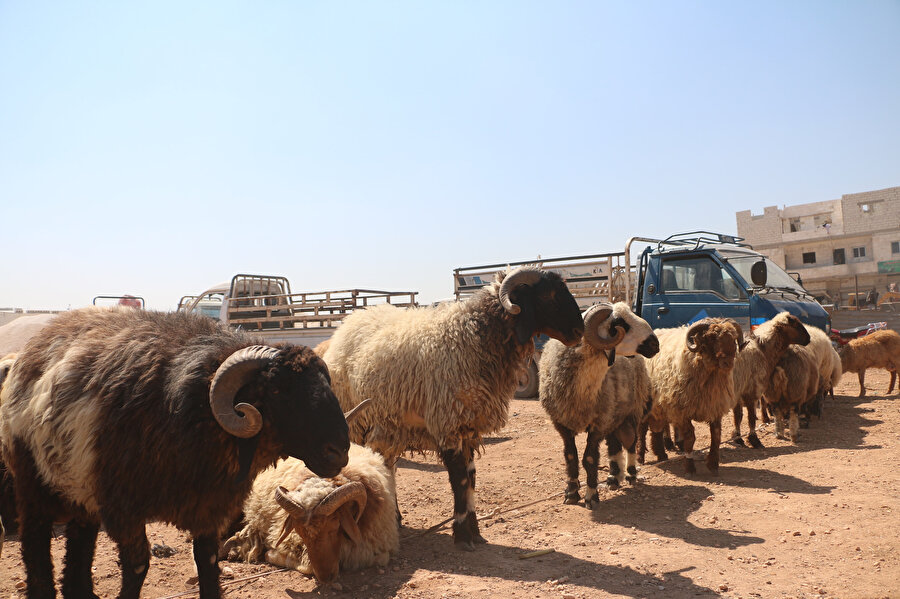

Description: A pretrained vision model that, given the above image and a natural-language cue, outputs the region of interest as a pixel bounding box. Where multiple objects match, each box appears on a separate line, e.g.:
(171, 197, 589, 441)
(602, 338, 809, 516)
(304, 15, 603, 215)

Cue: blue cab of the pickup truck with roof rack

(634, 231, 831, 333)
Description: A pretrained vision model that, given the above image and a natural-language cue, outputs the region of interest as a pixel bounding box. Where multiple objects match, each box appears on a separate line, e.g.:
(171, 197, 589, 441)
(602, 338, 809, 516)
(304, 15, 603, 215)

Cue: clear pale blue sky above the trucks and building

(0, 0, 900, 309)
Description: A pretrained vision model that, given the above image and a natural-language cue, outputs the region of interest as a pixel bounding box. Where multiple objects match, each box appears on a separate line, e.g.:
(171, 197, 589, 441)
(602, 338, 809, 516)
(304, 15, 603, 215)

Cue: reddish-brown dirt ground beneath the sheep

(0, 371, 900, 599)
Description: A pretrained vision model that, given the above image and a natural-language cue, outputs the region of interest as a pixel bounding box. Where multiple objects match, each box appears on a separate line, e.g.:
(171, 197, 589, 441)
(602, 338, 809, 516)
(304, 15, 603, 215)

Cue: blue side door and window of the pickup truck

(642, 254, 750, 331)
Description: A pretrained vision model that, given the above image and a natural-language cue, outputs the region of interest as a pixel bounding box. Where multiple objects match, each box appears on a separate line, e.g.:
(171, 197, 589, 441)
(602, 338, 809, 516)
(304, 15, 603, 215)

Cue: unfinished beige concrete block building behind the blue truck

(736, 187, 900, 305)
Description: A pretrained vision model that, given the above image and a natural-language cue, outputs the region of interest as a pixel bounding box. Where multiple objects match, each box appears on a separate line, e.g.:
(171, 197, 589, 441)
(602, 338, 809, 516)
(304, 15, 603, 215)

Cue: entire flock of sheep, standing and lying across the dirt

(0, 267, 900, 598)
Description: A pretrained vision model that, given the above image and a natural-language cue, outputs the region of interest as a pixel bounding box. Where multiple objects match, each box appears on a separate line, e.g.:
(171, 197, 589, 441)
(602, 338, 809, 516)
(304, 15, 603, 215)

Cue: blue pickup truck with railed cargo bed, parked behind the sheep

(454, 231, 831, 397)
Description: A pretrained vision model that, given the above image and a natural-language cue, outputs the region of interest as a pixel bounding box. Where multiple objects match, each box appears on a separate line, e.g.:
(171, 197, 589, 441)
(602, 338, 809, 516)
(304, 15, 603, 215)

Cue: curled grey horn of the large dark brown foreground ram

(209, 345, 278, 439)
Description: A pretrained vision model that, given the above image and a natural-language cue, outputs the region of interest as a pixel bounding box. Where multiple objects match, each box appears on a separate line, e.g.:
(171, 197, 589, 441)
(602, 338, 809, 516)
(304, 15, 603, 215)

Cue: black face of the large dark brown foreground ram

(256, 346, 350, 477)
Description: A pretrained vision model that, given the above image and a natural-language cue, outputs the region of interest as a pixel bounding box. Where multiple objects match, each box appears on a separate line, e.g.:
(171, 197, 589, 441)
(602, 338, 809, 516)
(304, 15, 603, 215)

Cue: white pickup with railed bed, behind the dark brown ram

(178, 274, 418, 347)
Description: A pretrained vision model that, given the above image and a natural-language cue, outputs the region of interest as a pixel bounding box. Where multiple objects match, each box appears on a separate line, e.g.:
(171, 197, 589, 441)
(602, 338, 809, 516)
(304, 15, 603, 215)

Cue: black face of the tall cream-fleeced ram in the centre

(509, 272, 584, 347)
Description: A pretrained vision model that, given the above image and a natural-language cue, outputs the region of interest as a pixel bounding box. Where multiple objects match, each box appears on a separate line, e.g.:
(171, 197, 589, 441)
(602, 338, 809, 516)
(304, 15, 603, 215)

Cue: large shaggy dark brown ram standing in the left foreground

(0, 308, 350, 599)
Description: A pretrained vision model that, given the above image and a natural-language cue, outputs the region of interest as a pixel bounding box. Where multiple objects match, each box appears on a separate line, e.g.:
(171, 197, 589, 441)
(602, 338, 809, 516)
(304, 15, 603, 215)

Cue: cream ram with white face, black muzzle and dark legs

(540, 302, 659, 509)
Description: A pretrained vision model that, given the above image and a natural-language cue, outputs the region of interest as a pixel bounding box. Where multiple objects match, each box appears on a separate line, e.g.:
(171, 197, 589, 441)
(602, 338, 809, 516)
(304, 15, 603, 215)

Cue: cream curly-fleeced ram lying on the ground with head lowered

(220, 438, 400, 582)
